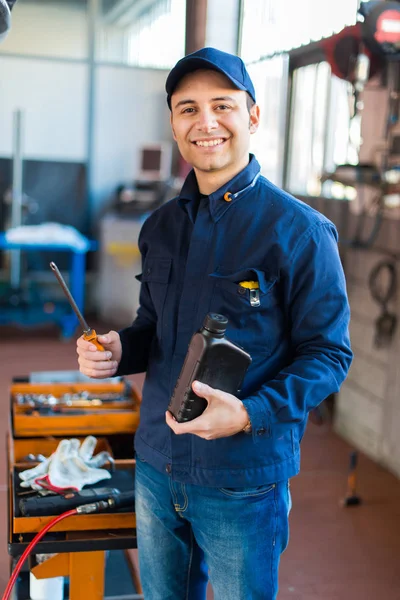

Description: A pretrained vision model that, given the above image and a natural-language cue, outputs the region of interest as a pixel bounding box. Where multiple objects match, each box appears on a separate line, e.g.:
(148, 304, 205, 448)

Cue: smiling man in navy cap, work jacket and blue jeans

(78, 48, 352, 600)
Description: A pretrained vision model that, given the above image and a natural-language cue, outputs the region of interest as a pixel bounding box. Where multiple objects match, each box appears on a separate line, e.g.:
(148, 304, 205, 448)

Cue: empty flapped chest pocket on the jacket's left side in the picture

(136, 256, 172, 339)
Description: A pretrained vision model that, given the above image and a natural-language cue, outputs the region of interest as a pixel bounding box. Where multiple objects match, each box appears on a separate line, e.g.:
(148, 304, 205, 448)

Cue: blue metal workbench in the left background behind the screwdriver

(0, 233, 97, 339)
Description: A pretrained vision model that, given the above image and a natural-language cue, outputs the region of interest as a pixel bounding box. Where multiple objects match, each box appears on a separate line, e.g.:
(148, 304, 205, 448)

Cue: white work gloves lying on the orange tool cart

(19, 436, 111, 492)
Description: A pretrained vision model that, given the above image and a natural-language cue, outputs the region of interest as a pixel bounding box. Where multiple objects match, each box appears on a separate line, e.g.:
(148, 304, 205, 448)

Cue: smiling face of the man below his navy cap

(171, 70, 259, 181)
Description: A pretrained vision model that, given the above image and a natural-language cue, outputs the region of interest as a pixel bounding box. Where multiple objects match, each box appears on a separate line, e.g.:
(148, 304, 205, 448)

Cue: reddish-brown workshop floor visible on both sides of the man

(0, 327, 400, 600)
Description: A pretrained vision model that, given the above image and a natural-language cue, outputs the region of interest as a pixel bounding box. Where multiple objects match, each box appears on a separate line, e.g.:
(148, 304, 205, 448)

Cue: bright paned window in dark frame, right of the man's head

(286, 62, 358, 198)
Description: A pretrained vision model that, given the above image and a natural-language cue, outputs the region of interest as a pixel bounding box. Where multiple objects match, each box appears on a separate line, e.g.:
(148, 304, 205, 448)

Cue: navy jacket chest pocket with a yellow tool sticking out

(210, 268, 283, 358)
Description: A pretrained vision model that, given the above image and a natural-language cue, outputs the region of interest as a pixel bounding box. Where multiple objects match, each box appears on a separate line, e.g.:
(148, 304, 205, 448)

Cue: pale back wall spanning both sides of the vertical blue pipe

(0, 0, 172, 219)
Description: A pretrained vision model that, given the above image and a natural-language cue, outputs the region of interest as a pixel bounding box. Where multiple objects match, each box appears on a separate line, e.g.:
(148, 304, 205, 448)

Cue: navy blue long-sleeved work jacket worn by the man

(118, 155, 352, 487)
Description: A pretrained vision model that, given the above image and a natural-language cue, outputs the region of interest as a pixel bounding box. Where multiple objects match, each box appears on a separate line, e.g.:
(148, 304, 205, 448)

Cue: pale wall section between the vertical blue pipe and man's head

(92, 66, 172, 214)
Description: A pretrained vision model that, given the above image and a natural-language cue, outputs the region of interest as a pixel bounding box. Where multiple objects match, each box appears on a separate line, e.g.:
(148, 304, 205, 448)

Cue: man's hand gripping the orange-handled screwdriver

(76, 331, 122, 379)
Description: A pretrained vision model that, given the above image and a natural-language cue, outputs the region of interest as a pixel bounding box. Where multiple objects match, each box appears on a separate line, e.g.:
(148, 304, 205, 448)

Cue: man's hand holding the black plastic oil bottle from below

(166, 381, 249, 440)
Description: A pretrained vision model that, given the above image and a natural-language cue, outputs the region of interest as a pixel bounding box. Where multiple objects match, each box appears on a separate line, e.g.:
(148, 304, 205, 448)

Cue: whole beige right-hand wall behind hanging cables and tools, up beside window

(304, 74, 400, 477)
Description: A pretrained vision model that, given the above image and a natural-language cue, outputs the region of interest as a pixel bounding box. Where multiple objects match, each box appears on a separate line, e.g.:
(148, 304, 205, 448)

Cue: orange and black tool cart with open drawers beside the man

(7, 382, 142, 600)
